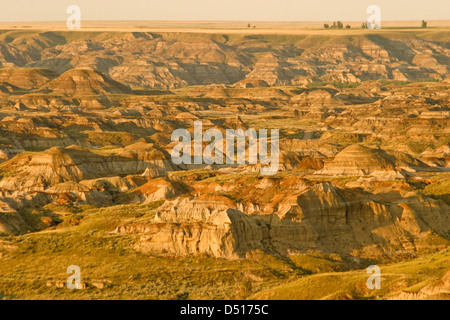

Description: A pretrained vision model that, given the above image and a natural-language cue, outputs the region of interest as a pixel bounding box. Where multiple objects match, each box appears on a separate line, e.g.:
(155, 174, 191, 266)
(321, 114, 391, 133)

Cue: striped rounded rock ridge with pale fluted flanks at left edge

(0, 143, 172, 192)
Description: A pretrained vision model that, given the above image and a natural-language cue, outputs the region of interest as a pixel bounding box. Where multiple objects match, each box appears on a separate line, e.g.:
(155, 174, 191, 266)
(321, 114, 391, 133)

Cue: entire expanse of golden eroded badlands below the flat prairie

(0, 27, 450, 299)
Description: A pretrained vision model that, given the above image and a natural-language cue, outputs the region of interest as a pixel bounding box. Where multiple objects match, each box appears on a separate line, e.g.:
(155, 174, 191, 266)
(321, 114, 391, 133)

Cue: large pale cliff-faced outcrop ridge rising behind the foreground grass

(112, 183, 450, 259)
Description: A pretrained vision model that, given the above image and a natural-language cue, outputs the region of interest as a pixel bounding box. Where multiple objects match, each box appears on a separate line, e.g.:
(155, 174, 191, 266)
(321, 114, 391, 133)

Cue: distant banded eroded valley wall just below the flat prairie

(0, 31, 449, 89)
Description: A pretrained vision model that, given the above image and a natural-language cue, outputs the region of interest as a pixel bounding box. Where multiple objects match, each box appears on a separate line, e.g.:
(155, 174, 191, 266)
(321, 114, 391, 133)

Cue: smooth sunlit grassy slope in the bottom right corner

(252, 249, 450, 300)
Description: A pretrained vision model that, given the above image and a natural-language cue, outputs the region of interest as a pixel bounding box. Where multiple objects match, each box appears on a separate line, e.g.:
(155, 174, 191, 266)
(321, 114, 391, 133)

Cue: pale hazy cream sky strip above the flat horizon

(0, 0, 450, 22)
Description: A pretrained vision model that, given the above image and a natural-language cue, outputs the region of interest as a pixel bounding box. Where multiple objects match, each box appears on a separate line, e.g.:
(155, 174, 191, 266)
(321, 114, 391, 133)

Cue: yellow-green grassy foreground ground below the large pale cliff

(0, 202, 450, 299)
